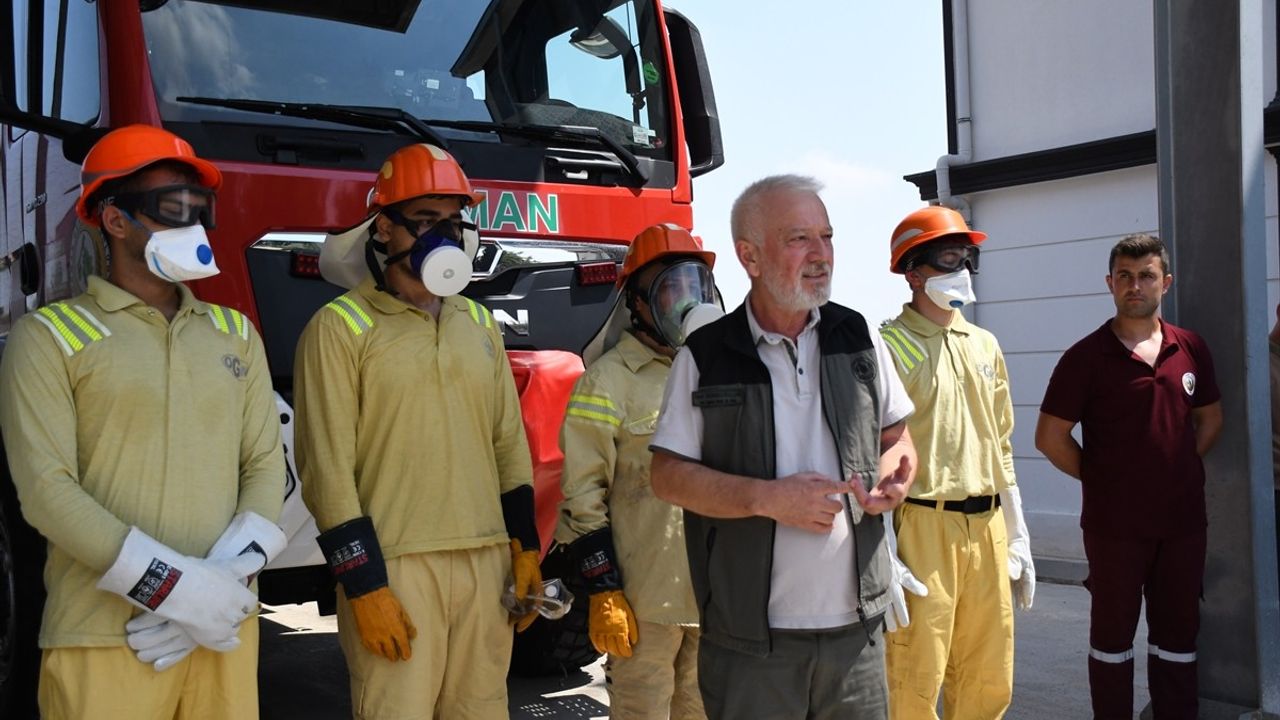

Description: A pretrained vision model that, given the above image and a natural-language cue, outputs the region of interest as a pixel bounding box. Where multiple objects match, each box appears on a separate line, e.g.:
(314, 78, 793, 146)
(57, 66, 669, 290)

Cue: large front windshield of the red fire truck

(142, 0, 671, 160)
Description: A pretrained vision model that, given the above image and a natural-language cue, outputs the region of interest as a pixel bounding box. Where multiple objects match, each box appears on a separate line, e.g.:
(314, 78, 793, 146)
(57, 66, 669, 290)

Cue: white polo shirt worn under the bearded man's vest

(650, 301, 915, 630)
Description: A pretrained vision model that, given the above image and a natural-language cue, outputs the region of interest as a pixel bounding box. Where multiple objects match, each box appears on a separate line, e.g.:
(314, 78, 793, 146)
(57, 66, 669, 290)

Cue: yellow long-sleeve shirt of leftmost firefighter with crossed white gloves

(0, 277, 284, 647)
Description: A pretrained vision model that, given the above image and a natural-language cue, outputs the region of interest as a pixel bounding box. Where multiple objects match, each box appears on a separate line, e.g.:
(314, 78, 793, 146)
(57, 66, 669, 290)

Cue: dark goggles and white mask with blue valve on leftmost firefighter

(104, 184, 219, 282)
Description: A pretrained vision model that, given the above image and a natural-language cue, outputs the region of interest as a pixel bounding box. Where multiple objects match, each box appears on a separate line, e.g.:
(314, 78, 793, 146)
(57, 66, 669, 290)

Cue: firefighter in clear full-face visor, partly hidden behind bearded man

(556, 224, 723, 720)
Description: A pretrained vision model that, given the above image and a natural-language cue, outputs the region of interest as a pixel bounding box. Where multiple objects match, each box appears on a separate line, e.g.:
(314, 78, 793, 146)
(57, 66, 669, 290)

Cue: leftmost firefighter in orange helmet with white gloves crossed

(0, 126, 285, 720)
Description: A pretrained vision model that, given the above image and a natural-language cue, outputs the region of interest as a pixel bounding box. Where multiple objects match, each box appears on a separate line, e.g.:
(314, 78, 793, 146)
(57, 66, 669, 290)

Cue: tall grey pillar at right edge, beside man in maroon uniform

(1162, 0, 1280, 719)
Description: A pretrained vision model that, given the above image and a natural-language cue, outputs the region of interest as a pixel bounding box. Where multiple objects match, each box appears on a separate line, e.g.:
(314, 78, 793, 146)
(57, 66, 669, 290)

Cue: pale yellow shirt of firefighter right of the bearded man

(881, 305, 1018, 500)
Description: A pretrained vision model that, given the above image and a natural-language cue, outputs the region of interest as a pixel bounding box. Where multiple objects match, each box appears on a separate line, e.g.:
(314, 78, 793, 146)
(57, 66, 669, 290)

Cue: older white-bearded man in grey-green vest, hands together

(650, 176, 915, 720)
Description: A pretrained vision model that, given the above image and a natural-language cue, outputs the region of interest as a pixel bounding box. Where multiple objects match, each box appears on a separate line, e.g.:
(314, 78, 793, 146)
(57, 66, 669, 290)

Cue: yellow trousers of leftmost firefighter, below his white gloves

(38, 615, 259, 720)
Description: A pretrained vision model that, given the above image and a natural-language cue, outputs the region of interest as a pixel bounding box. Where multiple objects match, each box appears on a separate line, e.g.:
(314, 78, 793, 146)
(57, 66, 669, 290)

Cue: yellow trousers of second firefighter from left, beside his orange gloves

(338, 544, 512, 720)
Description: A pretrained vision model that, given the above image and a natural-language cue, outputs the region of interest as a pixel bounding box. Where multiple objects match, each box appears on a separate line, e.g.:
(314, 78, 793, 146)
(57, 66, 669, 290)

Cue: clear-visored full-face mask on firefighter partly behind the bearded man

(631, 260, 724, 347)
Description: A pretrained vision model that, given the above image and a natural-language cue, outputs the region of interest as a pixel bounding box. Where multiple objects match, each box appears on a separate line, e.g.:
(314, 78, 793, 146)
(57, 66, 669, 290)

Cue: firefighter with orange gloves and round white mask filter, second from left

(294, 145, 541, 720)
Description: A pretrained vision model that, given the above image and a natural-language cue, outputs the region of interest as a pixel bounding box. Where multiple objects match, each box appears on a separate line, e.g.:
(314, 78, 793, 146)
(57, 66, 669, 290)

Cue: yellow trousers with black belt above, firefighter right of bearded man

(884, 503, 1014, 720)
